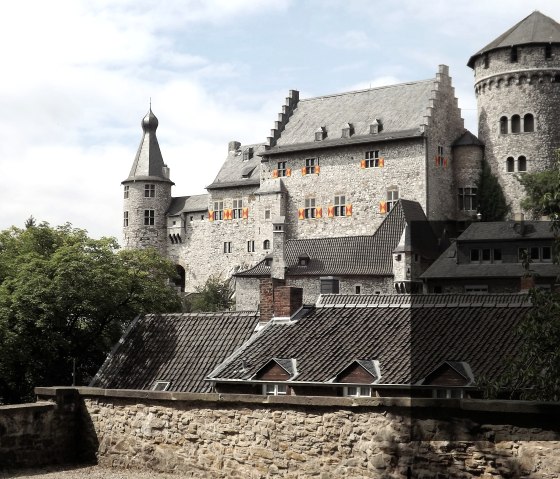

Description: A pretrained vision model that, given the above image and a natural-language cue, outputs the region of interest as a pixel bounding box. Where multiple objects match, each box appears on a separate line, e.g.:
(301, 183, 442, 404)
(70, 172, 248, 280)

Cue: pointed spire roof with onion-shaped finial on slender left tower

(123, 107, 173, 183)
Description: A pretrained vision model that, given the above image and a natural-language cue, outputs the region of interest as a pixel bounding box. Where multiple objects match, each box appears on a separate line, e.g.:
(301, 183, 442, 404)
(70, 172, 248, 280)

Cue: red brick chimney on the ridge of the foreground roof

(259, 278, 303, 323)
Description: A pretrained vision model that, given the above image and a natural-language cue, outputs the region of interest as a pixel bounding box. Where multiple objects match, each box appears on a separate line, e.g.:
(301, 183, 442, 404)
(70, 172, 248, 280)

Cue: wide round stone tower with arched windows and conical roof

(468, 11, 560, 217)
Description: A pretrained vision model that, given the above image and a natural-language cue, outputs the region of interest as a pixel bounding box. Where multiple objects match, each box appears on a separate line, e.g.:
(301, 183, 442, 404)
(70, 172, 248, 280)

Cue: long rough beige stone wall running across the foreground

(34, 388, 560, 479)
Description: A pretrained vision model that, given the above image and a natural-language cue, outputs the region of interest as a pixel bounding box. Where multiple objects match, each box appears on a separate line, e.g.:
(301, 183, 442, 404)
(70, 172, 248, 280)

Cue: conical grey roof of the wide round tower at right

(467, 10, 560, 68)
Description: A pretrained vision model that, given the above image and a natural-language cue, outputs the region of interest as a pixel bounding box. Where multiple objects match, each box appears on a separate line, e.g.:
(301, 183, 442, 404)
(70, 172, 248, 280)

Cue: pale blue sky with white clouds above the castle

(0, 0, 560, 238)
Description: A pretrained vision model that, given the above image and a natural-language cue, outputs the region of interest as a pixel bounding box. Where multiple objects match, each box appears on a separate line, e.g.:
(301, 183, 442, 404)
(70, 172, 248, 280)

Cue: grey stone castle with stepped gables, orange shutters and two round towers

(122, 11, 560, 308)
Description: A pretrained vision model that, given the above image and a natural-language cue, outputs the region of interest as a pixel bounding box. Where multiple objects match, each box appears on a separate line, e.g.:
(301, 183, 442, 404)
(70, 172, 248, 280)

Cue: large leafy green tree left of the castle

(0, 223, 180, 402)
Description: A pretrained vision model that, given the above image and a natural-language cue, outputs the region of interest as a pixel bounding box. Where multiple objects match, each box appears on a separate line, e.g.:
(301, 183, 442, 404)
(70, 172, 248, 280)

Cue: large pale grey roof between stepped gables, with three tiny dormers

(277, 80, 435, 148)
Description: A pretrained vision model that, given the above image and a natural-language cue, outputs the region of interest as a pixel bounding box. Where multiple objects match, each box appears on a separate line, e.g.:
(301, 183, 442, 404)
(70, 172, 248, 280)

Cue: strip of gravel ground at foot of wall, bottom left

(0, 466, 180, 479)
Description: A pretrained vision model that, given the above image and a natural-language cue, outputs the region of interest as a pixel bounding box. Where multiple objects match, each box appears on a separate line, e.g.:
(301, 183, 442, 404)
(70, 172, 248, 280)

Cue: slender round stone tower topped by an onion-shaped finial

(122, 108, 173, 254)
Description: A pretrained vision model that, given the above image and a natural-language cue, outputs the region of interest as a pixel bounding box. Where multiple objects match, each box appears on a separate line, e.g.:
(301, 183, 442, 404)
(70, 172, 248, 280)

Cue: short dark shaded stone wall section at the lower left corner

(0, 389, 78, 469)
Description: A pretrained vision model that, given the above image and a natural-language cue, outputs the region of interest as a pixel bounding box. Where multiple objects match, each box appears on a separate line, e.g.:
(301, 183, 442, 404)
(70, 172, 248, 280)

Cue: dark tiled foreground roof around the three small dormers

(209, 295, 530, 385)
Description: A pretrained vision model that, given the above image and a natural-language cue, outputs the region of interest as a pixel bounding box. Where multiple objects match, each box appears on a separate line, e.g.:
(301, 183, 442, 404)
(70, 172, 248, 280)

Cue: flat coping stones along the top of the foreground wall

(34, 386, 560, 417)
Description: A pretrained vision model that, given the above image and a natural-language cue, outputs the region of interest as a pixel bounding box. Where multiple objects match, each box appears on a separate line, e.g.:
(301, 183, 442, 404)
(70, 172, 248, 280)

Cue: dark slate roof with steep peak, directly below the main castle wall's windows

(236, 199, 437, 277)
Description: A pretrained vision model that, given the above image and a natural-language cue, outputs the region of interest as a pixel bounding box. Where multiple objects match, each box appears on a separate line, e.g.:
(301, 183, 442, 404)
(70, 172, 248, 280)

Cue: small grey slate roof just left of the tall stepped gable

(206, 144, 264, 190)
